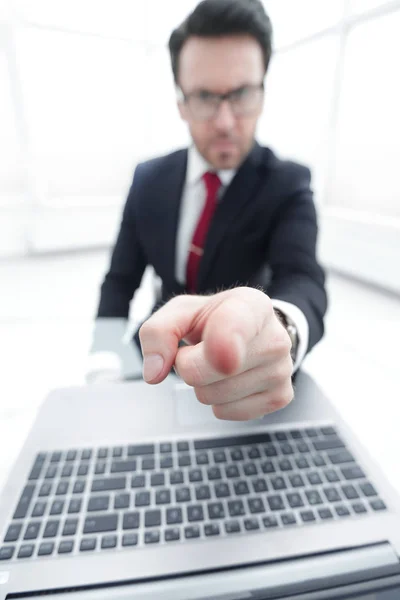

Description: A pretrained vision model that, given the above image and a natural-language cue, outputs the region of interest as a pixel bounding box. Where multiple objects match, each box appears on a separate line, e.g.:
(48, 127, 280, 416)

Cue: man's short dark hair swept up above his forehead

(168, 0, 272, 83)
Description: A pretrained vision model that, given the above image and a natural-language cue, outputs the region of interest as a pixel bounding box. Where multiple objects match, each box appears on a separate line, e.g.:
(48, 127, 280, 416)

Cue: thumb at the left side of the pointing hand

(139, 296, 208, 384)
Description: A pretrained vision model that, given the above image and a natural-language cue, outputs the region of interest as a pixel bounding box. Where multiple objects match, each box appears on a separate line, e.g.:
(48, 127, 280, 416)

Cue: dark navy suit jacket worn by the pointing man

(98, 144, 327, 350)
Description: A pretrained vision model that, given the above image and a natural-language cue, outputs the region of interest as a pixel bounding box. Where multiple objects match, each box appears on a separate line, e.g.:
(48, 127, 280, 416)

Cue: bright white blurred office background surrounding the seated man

(0, 0, 400, 482)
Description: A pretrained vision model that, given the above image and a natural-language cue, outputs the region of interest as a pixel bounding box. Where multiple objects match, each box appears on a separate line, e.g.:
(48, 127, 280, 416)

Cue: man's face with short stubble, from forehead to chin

(178, 36, 265, 169)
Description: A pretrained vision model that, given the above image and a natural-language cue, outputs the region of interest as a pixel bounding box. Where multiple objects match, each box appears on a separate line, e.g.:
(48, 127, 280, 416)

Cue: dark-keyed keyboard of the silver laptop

(0, 427, 387, 561)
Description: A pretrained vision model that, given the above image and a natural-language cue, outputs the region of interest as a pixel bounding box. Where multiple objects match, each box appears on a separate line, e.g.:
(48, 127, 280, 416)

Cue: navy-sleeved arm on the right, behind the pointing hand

(268, 167, 327, 354)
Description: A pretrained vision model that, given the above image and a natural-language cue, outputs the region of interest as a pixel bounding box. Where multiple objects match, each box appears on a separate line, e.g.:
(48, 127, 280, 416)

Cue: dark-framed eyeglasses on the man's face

(181, 83, 264, 121)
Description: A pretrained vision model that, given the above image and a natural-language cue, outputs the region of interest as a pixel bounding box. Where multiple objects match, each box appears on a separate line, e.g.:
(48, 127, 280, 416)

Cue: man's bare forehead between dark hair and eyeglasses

(179, 36, 264, 93)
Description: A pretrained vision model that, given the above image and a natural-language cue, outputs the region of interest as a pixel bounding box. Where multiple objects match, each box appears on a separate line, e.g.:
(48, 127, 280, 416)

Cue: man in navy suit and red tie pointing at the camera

(94, 0, 326, 419)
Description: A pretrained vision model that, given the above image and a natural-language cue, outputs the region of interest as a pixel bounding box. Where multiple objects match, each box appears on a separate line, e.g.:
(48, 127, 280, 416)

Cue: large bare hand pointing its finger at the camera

(139, 287, 293, 421)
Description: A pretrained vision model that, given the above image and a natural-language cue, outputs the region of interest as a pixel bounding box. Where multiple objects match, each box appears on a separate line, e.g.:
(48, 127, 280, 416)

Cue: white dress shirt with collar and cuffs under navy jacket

(87, 146, 309, 380)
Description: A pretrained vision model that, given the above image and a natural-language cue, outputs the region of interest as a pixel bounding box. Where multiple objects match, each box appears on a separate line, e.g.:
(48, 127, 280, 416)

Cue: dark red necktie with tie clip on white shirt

(186, 172, 221, 293)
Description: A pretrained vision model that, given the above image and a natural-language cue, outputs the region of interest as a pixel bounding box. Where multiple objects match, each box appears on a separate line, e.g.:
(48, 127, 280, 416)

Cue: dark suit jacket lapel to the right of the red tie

(198, 143, 265, 291)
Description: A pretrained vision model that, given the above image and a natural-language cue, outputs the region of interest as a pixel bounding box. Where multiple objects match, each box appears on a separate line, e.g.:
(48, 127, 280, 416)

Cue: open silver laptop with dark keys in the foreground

(0, 364, 400, 600)
